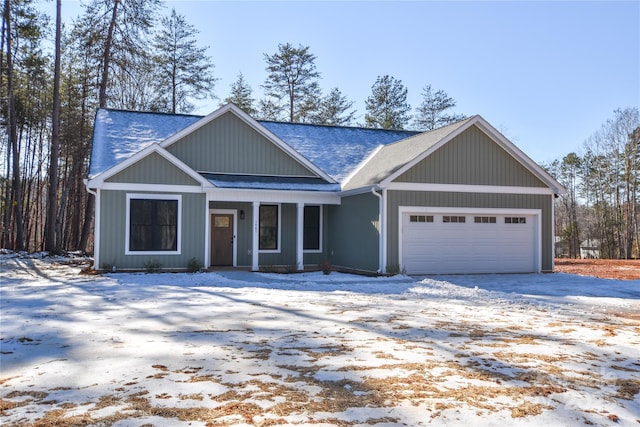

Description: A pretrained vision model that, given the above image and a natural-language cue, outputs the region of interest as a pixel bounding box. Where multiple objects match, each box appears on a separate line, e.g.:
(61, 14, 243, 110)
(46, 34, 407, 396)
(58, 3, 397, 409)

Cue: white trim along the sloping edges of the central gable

(160, 104, 336, 183)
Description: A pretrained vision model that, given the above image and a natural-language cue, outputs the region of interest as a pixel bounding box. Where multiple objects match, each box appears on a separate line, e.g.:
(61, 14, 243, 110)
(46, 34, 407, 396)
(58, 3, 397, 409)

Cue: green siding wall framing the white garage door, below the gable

(387, 190, 553, 271)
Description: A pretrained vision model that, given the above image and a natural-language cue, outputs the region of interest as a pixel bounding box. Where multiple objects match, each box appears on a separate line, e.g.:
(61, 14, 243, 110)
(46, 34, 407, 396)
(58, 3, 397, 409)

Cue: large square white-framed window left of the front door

(125, 194, 181, 254)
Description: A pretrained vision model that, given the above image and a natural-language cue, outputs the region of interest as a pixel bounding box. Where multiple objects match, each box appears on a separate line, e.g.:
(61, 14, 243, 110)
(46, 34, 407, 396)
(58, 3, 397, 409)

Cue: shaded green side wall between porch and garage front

(329, 193, 380, 271)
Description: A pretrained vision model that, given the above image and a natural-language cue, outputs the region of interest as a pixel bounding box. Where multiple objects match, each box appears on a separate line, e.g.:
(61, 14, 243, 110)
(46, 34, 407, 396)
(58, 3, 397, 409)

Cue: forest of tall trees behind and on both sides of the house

(0, 0, 640, 259)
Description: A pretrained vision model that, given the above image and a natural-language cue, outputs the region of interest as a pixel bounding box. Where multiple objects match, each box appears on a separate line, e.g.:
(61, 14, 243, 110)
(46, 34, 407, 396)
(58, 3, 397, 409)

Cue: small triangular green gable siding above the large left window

(106, 153, 200, 185)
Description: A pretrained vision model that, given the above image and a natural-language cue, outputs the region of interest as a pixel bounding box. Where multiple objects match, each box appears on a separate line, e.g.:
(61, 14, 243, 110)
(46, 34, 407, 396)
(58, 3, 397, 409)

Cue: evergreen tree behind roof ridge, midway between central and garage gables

(364, 75, 411, 129)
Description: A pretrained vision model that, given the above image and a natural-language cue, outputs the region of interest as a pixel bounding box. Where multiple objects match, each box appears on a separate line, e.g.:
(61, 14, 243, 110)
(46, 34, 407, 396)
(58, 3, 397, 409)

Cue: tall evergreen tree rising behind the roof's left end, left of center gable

(153, 9, 216, 113)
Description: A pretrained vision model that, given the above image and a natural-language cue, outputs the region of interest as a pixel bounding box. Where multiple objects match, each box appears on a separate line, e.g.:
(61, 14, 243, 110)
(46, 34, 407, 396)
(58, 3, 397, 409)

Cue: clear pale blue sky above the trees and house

(49, 0, 640, 163)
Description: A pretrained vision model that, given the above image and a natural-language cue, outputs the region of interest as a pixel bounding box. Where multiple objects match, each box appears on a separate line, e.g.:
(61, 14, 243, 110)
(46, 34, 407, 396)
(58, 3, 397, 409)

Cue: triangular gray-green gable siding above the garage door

(395, 126, 546, 187)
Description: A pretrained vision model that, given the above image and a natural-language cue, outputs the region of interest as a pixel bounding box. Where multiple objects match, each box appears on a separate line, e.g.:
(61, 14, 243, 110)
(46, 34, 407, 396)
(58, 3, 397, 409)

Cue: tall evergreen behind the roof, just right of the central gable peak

(261, 43, 320, 122)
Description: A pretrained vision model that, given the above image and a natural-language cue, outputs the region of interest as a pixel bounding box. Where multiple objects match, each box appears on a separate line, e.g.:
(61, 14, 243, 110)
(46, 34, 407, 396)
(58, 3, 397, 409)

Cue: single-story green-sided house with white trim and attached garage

(86, 104, 564, 274)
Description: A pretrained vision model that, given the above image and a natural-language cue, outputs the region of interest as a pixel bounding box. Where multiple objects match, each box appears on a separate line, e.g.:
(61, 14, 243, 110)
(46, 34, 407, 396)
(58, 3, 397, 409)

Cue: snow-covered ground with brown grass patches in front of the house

(0, 254, 640, 426)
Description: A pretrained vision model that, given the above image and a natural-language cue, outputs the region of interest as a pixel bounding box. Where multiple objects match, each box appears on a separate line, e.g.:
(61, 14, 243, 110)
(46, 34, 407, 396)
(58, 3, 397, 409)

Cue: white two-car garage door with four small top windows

(401, 212, 538, 274)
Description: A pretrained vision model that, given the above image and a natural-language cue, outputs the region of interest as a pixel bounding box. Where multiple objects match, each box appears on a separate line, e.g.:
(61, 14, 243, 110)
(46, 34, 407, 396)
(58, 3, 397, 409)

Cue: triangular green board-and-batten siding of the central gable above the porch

(166, 112, 316, 176)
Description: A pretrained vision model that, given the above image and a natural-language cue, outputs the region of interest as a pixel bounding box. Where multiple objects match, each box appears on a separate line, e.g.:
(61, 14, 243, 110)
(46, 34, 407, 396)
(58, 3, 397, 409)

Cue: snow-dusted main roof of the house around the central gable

(89, 104, 418, 182)
